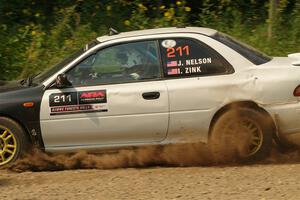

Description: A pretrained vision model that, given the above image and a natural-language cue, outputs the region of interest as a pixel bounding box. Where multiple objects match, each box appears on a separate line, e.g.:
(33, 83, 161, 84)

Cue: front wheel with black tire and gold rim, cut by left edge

(0, 117, 30, 167)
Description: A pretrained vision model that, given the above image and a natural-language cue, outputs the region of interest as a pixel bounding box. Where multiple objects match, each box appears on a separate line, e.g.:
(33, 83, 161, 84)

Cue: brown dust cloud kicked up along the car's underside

(7, 143, 300, 172)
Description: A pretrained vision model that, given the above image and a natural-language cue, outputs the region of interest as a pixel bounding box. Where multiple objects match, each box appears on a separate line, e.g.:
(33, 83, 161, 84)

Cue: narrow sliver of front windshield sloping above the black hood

(33, 40, 99, 83)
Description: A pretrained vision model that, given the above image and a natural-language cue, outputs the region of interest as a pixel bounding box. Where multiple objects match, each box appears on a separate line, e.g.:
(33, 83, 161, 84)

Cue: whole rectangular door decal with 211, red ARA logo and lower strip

(49, 90, 108, 115)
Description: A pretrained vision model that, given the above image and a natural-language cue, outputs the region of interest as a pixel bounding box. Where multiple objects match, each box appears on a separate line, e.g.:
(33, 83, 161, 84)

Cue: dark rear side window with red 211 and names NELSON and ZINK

(159, 38, 233, 77)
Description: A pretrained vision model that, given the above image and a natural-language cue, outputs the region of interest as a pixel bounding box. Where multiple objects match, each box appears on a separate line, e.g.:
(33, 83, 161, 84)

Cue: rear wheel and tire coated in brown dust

(210, 107, 273, 162)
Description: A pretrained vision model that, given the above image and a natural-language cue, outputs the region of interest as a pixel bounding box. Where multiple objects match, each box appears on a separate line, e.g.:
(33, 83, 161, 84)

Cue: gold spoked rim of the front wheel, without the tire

(0, 126, 17, 166)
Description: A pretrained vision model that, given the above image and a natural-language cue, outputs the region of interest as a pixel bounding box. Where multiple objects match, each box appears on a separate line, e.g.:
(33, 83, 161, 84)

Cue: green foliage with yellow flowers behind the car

(0, 0, 300, 79)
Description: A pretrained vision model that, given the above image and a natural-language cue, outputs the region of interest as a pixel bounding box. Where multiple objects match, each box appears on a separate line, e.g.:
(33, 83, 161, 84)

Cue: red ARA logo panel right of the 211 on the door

(78, 90, 107, 104)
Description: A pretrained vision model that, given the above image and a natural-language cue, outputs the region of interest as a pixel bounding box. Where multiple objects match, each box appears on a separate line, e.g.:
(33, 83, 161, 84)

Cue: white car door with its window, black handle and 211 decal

(41, 41, 169, 149)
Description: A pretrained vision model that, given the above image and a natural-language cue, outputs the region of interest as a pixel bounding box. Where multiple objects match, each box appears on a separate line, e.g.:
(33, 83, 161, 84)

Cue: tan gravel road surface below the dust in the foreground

(0, 164, 300, 200)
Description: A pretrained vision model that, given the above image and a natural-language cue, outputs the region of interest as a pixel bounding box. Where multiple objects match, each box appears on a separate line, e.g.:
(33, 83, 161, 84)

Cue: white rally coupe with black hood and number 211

(0, 28, 300, 165)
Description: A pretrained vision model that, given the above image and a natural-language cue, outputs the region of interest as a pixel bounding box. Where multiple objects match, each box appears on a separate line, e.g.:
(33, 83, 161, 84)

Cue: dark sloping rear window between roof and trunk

(212, 32, 272, 65)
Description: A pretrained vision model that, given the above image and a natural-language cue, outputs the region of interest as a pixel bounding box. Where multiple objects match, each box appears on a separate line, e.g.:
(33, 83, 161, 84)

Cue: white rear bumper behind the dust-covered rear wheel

(265, 102, 300, 146)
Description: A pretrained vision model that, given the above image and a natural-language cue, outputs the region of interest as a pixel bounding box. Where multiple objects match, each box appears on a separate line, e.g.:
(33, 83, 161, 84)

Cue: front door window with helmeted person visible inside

(66, 41, 161, 86)
